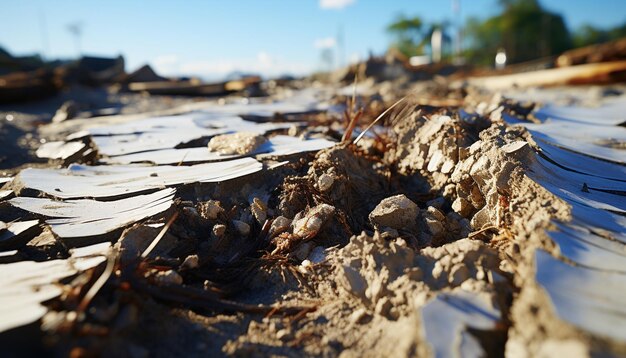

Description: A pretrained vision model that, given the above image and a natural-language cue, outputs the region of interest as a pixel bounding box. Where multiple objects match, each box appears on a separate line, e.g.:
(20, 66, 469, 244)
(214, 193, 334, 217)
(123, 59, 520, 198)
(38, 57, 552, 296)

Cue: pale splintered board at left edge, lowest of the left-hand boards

(0, 243, 110, 332)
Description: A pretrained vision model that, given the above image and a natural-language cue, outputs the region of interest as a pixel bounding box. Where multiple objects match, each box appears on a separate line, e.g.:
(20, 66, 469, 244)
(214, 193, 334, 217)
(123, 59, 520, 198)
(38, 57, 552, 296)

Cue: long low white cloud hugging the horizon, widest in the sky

(151, 51, 313, 80)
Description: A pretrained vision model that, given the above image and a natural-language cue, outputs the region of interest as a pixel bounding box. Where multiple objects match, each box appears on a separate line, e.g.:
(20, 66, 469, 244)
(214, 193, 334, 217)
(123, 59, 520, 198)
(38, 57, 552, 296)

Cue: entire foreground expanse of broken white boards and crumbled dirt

(0, 76, 626, 356)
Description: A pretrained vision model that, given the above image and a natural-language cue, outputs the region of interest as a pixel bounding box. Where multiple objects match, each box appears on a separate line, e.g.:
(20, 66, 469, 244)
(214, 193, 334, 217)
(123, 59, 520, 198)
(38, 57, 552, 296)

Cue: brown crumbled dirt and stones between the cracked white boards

(0, 79, 626, 357)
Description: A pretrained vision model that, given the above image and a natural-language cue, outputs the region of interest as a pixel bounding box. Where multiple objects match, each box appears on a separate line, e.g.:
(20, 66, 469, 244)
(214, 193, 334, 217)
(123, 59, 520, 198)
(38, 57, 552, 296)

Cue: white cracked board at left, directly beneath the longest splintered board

(9, 189, 175, 239)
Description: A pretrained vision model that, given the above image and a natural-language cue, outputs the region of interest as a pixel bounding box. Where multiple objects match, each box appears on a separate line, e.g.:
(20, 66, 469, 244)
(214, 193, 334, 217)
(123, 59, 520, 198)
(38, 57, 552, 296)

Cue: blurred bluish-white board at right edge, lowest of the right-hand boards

(535, 250, 626, 341)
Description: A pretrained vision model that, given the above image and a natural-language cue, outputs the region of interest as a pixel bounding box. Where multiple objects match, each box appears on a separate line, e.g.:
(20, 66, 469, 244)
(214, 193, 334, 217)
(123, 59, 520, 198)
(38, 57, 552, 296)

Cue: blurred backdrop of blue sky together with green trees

(0, 0, 626, 81)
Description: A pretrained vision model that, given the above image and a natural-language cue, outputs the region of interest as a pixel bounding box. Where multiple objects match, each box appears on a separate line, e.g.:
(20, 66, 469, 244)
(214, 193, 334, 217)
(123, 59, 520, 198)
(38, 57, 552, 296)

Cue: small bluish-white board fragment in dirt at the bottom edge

(422, 290, 501, 357)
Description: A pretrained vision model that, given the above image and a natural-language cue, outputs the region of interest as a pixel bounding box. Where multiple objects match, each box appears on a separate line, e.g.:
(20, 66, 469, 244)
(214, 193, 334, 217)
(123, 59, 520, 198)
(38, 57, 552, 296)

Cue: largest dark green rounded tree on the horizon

(466, 0, 572, 64)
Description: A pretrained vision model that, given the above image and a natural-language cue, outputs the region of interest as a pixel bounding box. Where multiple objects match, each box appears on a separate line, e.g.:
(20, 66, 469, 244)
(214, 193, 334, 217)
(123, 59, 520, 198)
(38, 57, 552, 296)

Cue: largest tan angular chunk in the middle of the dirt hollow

(369, 194, 419, 229)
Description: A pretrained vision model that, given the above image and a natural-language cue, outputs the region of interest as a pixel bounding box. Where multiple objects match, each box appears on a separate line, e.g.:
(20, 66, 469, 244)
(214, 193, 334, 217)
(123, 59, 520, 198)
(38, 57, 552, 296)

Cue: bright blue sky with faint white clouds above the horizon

(0, 0, 626, 78)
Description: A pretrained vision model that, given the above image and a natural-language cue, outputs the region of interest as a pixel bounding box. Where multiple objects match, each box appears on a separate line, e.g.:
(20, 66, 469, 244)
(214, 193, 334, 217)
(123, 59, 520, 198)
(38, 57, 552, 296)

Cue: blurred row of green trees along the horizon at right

(387, 0, 626, 65)
